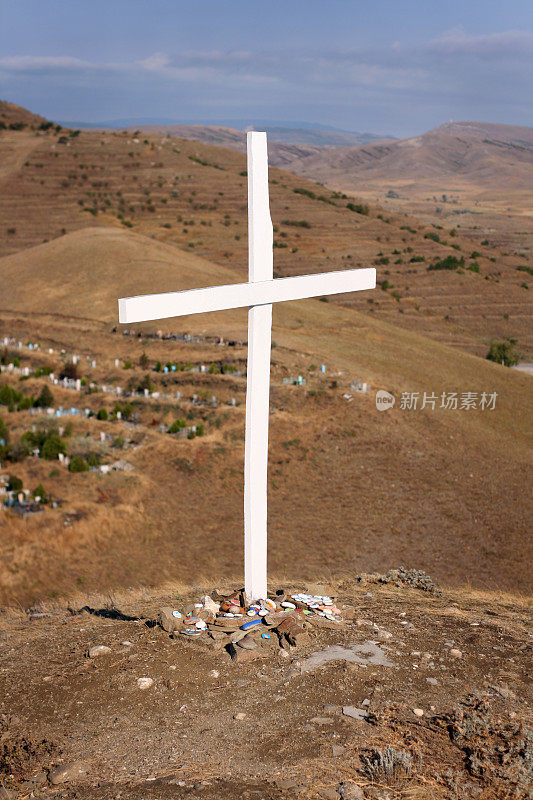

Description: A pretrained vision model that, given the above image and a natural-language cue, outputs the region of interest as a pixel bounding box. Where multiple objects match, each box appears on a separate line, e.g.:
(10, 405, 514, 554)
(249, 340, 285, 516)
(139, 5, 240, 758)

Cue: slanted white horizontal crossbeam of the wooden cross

(118, 267, 376, 323)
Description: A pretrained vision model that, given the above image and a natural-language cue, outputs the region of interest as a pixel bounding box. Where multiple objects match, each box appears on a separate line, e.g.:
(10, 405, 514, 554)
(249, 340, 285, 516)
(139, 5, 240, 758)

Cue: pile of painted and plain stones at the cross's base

(158, 589, 350, 661)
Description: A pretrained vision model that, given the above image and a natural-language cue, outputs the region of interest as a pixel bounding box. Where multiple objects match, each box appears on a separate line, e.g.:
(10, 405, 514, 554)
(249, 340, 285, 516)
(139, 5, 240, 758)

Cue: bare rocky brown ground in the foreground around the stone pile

(0, 571, 533, 800)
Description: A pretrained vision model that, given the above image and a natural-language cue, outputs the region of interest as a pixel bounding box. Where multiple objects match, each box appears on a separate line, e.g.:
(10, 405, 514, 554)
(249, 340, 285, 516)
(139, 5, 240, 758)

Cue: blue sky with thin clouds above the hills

(0, 0, 533, 136)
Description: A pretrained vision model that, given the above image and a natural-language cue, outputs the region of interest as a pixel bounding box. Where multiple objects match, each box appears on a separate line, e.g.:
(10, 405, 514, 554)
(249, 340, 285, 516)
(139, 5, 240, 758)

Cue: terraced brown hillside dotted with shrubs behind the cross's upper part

(0, 119, 533, 360)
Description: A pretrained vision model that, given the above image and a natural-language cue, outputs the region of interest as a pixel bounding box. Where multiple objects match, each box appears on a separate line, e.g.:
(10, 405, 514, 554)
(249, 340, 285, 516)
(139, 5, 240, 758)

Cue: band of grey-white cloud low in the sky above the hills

(0, 27, 533, 135)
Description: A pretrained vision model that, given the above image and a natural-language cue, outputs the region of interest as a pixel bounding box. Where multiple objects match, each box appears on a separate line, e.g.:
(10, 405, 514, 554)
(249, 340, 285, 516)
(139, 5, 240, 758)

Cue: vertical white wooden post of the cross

(244, 131, 274, 602)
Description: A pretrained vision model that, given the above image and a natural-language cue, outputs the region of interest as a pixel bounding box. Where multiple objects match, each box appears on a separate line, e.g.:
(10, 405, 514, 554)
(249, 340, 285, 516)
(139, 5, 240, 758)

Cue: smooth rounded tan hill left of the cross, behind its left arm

(0, 227, 239, 322)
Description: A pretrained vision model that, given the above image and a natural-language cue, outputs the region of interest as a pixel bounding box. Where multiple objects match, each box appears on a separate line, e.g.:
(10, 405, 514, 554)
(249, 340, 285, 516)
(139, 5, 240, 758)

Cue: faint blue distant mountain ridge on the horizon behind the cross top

(58, 117, 394, 147)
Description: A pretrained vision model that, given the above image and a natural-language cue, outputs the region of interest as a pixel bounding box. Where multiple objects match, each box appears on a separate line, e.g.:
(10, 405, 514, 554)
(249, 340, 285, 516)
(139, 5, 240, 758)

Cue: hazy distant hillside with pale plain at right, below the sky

(264, 122, 533, 268)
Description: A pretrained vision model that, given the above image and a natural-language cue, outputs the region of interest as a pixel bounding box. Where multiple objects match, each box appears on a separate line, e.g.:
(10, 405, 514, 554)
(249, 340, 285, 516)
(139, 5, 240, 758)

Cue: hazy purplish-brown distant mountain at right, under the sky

(268, 122, 533, 197)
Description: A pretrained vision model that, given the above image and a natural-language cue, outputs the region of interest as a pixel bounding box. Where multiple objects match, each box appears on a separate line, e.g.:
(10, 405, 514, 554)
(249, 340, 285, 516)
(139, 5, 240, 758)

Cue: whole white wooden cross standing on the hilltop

(118, 131, 376, 602)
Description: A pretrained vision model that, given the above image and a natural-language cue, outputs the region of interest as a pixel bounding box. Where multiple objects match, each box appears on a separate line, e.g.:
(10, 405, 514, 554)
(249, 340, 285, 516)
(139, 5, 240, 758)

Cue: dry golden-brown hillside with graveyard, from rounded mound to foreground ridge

(0, 228, 530, 600)
